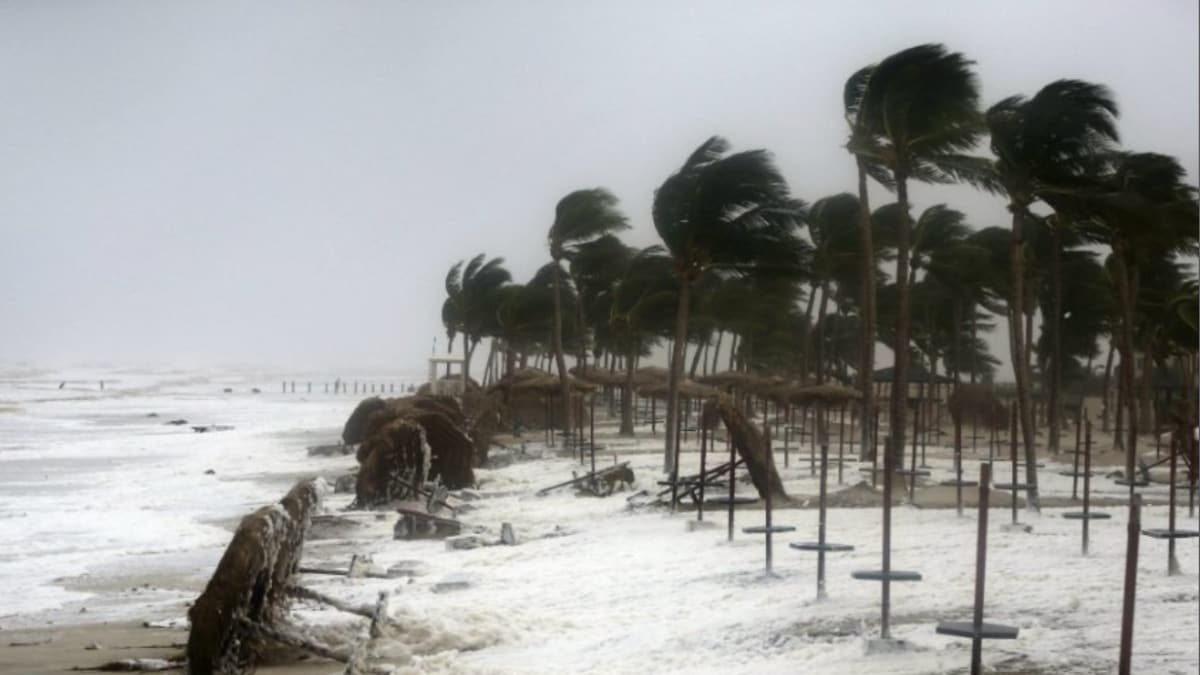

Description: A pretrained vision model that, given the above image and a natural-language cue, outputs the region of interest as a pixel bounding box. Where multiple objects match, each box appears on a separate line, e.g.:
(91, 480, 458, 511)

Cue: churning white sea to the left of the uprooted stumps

(0, 368, 419, 626)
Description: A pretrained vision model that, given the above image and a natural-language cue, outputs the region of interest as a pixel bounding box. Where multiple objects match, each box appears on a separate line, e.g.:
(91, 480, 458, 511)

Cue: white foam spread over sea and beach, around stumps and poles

(0, 374, 1200, 675)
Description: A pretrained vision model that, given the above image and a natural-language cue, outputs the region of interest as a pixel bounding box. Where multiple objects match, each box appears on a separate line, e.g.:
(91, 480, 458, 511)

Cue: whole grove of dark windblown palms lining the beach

(443, 44, 1200, 508)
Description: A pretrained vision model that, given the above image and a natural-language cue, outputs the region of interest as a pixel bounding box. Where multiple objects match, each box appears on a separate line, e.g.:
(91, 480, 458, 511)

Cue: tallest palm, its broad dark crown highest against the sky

(846, 44, 991, 480)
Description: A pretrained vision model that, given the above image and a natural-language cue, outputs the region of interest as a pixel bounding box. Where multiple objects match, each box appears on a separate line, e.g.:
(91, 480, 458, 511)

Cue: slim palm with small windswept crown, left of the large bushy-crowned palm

(547, 187, 629, 442)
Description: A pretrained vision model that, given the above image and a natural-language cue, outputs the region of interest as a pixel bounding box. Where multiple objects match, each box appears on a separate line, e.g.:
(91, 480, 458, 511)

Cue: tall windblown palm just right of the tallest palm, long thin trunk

(986, 79, 1117, 509)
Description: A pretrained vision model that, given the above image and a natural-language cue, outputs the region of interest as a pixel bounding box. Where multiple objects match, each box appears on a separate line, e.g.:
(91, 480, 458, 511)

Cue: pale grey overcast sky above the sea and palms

(0, 0, 1200, 368)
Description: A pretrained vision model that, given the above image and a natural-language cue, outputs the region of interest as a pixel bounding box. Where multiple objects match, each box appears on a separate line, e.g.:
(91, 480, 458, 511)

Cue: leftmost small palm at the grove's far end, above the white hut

(442, 253, 512, 378)
